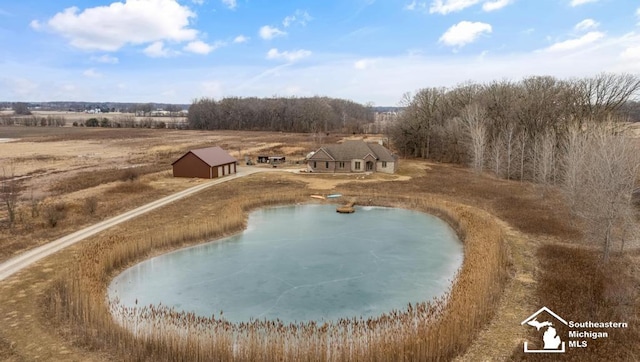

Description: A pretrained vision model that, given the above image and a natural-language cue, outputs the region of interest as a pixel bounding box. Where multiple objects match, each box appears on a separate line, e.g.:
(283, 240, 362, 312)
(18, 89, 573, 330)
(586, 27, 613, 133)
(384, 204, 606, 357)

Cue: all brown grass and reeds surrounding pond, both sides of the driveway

(0, 123, 640, 361)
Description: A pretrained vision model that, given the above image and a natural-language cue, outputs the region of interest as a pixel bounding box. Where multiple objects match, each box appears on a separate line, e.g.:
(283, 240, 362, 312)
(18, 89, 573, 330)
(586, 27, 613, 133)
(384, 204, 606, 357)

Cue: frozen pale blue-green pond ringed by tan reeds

(109, 205, 463, 322)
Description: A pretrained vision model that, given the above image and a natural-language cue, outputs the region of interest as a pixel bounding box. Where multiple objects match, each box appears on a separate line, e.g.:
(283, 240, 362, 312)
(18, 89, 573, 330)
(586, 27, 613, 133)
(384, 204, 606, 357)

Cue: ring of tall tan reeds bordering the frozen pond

(45, 190, 508, 361)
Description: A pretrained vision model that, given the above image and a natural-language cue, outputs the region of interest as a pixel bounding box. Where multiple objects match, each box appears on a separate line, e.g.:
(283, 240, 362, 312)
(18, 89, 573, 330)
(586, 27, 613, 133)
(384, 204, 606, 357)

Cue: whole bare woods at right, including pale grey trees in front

(389, 74, 640, 259)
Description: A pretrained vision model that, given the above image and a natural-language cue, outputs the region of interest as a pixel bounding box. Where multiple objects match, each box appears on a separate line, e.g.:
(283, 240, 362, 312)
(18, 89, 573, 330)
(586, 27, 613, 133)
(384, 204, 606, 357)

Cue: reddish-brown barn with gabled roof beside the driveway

(171, 146, 238, 178)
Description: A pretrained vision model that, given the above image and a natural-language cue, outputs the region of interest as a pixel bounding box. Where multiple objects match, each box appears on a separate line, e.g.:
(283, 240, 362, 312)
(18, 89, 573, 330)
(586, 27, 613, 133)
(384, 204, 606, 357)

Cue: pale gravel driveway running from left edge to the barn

(0, 167, 294, 281)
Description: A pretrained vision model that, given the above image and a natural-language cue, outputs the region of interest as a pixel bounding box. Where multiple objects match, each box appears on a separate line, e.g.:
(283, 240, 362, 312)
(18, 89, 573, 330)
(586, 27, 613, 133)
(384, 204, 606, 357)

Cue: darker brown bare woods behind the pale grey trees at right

(389, 74, 640, 174)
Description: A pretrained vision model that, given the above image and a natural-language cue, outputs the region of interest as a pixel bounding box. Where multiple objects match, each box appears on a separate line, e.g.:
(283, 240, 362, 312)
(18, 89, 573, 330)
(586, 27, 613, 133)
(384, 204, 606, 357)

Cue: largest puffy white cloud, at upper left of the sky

(43, 0, 198, 51)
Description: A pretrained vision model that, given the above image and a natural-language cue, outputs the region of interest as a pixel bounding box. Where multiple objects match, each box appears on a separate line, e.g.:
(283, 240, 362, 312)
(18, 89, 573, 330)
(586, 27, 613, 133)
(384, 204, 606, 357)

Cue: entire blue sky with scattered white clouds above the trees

(0, 0, 640, 106)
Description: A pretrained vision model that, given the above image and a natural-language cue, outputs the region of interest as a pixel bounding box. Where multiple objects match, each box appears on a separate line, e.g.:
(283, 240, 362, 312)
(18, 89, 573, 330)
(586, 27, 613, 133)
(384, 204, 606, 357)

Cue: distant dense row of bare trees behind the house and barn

(187, 97, 374, 133)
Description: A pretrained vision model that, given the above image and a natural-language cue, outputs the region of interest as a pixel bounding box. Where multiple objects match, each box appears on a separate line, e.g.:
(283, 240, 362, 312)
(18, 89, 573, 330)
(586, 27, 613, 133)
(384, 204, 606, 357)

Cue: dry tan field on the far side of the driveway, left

(0, 127, 360, 261)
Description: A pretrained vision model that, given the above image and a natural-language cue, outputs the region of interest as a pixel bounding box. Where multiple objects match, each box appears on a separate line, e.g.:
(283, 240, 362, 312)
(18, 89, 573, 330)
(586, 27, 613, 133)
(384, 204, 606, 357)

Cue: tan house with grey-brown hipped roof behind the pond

(307, 140, 398, 173)
